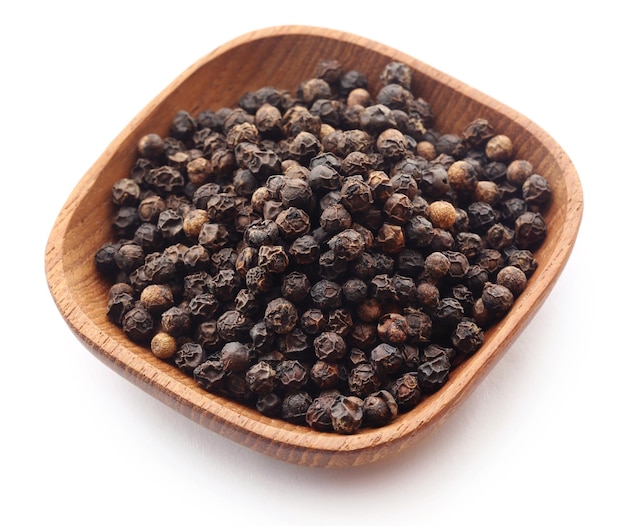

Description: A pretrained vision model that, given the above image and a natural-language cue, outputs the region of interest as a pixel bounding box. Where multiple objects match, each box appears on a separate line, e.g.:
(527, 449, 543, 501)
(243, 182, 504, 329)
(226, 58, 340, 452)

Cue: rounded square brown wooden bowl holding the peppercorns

(45, 26, 583, 467)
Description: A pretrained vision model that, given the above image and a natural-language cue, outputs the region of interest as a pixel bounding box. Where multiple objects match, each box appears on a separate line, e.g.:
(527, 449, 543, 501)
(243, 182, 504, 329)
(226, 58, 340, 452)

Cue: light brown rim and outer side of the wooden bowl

(45, 25, 583, 467)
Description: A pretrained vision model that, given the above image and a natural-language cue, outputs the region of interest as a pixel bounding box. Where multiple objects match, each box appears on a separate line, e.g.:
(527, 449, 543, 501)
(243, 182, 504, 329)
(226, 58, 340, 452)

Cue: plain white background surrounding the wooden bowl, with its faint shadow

(0, 0, 626, 526)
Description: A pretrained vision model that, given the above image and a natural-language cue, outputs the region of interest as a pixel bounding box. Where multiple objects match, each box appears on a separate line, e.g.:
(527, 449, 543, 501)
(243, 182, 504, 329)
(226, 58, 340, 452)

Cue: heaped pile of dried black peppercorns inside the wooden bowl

(95, 60, 551, 433)
